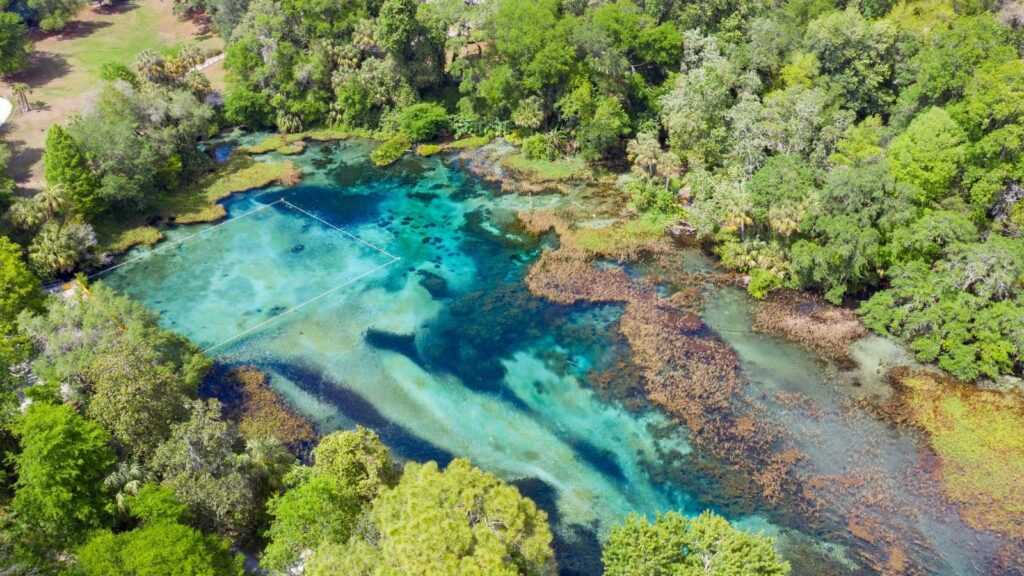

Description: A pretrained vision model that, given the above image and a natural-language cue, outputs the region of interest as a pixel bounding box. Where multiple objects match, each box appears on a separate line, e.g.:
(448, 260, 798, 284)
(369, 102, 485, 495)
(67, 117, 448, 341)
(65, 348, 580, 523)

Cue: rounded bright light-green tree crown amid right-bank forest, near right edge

(889, 108, 966, 204)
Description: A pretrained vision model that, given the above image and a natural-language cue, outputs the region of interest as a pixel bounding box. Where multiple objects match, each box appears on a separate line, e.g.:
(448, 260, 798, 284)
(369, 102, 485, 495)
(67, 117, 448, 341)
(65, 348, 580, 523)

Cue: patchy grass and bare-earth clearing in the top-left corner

(0, 0, 223, 190)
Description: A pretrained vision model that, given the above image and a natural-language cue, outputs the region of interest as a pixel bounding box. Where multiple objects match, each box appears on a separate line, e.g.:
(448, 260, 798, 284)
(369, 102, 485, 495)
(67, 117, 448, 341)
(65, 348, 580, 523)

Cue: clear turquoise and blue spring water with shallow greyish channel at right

(101, 141, 1011, 574)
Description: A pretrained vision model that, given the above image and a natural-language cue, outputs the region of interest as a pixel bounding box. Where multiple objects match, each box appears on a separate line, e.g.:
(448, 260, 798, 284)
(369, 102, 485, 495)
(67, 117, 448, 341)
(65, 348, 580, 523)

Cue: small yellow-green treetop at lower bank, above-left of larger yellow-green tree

(313, 426, 398, 501)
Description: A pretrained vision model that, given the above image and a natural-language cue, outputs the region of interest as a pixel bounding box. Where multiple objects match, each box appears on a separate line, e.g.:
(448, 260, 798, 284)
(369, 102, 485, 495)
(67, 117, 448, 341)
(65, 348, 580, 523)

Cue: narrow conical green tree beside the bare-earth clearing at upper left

(43, 124, 102, 215)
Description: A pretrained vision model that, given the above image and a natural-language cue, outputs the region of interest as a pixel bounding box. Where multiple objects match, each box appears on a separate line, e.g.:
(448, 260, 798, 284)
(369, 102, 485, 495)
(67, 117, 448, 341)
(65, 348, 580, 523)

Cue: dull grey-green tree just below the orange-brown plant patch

(153, 400, 262, 541)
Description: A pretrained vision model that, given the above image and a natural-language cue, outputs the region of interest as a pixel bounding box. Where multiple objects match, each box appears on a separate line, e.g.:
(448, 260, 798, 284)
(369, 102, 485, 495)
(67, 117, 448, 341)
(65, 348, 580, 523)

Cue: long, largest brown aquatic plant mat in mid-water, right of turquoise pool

(519, 207, 800, 502)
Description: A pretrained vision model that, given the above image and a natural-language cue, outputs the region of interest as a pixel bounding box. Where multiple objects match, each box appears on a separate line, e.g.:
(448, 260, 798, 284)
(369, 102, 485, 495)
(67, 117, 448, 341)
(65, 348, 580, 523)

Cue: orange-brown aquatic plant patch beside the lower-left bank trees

(212, 366, 316, 455)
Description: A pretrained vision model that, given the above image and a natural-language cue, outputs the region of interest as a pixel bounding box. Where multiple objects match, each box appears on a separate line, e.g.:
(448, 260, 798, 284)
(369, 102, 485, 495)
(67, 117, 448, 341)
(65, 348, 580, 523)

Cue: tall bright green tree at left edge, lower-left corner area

(10, 402, 114, 558)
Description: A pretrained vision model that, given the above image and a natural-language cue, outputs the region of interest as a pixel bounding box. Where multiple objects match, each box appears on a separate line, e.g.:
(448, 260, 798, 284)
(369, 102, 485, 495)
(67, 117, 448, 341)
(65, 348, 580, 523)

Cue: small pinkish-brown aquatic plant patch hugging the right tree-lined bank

(754, 290, 867, 361)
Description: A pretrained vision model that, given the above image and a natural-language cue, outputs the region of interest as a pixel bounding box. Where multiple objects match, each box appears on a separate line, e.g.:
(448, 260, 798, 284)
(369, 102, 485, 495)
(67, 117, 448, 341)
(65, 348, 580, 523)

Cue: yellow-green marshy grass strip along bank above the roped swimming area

(95, 155, 301, 252)
